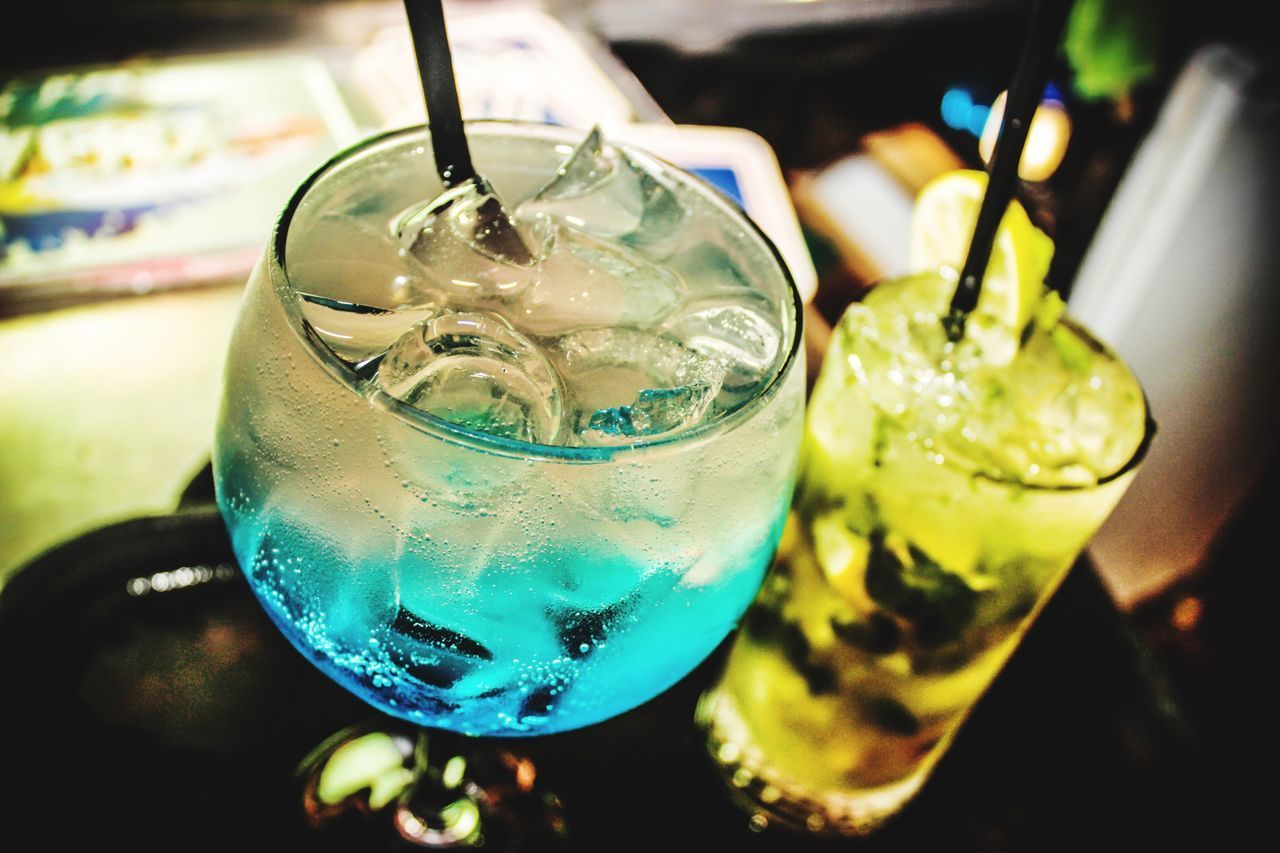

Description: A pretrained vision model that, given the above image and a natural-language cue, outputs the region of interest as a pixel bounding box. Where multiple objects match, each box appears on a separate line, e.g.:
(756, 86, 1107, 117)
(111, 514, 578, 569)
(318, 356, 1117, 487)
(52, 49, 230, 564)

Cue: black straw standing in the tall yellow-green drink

(943, 0, 1073, 341)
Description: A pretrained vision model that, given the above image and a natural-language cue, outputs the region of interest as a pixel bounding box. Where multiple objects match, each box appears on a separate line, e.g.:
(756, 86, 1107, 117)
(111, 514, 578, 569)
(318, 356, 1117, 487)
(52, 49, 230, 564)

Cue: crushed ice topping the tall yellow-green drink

(838, 273, 1147, 488)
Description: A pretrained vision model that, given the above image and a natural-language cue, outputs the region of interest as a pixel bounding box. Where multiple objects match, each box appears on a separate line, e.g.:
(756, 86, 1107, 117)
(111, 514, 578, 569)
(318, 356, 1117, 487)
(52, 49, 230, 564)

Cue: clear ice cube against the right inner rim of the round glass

(662, 297, 782, 393)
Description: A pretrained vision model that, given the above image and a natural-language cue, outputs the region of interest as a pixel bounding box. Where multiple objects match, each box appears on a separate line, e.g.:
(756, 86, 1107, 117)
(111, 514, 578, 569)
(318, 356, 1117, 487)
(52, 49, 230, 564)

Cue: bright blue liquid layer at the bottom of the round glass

(219, 471, 786, 736)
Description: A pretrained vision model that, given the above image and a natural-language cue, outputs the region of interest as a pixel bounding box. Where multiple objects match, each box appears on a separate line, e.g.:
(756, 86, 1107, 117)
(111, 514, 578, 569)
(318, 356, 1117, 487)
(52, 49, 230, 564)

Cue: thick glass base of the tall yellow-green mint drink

(698, 690, 929, 836)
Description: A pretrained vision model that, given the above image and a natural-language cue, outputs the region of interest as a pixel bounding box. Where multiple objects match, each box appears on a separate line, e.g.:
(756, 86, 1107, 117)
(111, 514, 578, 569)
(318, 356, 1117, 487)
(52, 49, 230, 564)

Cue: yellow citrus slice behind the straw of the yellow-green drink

(910, 169, 1053, 346)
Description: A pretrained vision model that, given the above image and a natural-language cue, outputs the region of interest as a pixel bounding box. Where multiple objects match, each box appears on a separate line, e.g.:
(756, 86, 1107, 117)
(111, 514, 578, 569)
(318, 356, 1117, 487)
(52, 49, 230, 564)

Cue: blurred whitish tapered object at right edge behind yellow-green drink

(1070, 45, 1280, 606)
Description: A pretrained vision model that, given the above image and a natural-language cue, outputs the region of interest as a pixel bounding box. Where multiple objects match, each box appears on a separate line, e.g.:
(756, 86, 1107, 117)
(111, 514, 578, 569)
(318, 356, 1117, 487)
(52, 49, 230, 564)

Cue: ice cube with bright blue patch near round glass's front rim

(553, 328, 724, 444)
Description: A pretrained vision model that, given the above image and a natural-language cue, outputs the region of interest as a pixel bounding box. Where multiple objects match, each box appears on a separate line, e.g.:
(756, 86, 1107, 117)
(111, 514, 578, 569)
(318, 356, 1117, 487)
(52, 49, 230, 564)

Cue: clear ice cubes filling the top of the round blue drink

(288, 128, 786, 446)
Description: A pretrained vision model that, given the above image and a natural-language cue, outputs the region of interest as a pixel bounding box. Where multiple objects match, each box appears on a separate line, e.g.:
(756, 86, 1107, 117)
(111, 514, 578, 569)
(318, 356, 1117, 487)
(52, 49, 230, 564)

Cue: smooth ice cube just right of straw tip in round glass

(512, 224, 685, 337)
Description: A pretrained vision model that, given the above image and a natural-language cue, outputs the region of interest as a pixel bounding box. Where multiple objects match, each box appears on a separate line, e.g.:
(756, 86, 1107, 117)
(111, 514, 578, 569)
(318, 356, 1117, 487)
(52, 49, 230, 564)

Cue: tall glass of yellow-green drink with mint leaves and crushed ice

(698, 268, 1153, 835)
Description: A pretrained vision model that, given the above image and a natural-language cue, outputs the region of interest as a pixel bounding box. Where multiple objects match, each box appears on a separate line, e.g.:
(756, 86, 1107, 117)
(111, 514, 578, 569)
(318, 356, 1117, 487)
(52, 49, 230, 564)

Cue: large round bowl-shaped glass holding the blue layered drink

(214, 122, 804, 835)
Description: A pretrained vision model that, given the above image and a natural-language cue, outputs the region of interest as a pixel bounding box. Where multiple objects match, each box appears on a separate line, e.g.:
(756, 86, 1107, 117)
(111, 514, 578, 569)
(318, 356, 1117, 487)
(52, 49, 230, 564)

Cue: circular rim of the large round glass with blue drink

(266, 119, 804, 462)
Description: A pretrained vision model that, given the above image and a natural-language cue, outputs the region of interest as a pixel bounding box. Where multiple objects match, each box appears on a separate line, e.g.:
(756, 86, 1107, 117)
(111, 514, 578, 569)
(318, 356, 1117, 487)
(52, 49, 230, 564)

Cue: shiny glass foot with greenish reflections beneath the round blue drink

(297, 720, 566, 852)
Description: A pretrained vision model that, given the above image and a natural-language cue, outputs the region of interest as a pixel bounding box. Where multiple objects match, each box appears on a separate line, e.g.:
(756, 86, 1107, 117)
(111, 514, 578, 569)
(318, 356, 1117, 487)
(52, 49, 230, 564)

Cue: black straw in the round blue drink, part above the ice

(404, 0, 476, 188)
